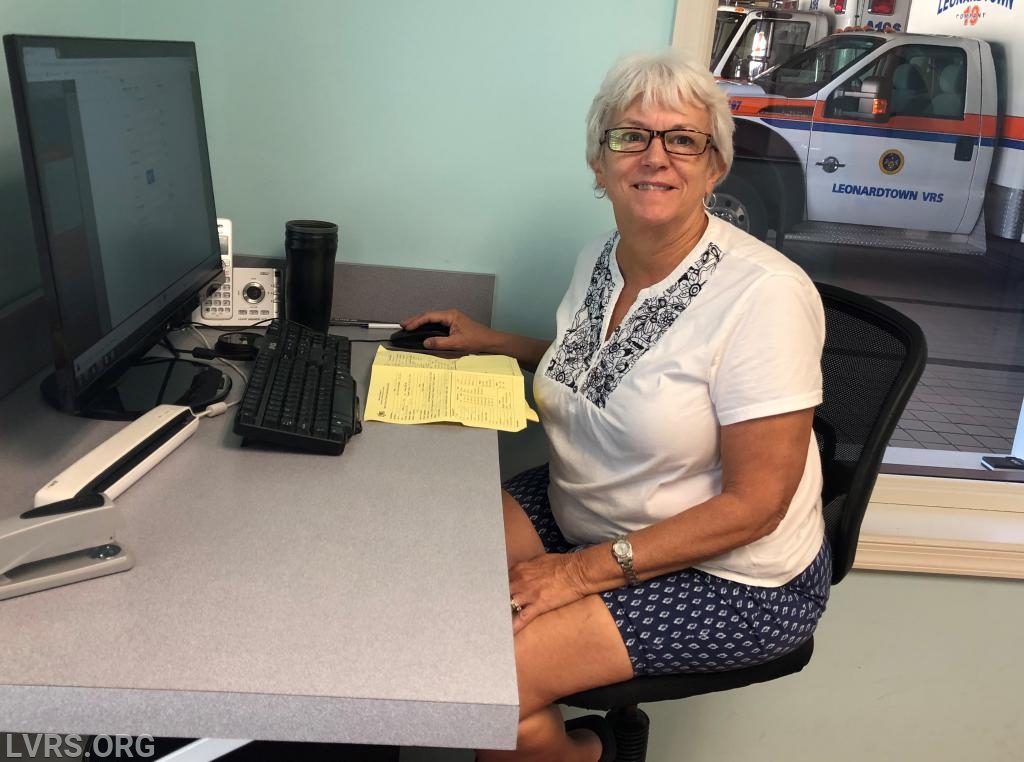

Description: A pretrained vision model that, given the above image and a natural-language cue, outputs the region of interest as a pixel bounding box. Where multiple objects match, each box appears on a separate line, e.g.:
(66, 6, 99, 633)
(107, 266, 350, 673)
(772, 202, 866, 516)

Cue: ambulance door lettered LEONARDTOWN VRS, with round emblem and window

(805, 43, 981, 232)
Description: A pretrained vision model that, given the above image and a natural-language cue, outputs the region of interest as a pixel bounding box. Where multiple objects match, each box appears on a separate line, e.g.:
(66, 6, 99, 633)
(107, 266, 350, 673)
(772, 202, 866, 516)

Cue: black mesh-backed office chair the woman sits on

(559, 284, 928, 762)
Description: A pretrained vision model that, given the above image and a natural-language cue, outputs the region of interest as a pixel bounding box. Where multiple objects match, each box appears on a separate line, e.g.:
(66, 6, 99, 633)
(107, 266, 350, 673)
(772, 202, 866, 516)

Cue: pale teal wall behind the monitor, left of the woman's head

(0, 0, 675, 335)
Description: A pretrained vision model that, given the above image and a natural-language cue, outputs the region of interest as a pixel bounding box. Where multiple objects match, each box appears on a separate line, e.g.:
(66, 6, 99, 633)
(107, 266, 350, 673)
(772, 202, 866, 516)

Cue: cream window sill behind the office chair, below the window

(854, 449, 1024, 580)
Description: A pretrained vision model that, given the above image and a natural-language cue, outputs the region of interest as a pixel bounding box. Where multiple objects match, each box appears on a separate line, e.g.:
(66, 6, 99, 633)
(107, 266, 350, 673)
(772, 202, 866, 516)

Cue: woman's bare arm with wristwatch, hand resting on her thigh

(509, 408, 814, 627)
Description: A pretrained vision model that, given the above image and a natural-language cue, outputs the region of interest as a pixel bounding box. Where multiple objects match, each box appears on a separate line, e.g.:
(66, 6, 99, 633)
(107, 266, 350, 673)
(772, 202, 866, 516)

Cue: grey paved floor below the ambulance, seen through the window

(783, 239, 1024, 454)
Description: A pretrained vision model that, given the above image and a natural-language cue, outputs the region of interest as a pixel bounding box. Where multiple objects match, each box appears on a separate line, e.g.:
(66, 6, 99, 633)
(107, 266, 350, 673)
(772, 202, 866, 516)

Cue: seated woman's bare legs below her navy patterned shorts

(478, 493, 633, 762)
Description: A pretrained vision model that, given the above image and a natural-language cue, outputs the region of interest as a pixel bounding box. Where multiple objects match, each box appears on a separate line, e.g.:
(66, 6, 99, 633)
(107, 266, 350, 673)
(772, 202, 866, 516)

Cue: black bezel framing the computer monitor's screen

(3, 34, 223, 414)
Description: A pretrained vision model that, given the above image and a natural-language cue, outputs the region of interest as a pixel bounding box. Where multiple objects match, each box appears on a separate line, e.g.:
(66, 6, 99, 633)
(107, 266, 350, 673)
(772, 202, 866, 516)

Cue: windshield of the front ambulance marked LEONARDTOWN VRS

(753, 34, 886, 98)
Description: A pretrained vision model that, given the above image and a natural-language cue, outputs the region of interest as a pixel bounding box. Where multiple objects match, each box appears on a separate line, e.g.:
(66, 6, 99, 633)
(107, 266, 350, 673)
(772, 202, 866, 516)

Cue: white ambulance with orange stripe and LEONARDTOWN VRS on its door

(713, 0, 1024, 248)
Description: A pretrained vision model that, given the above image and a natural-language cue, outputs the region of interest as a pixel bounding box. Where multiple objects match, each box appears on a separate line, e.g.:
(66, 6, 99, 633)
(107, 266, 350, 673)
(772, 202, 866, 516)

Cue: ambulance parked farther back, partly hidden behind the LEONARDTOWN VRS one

(711, 0, 910, 79)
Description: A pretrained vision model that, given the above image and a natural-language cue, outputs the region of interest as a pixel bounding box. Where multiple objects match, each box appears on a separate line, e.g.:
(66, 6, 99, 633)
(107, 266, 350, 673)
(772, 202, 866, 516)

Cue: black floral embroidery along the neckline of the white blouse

(546, 234, 722, 408)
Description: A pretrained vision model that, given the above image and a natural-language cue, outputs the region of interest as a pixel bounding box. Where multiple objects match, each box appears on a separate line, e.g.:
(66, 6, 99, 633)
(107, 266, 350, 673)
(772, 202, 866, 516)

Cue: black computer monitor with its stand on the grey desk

(3, 35, 230, 419)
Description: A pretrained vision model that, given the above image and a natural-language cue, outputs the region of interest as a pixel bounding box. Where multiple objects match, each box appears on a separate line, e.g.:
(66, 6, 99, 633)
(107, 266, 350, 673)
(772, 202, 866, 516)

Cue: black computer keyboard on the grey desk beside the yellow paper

(234, 320, 361, 455)
